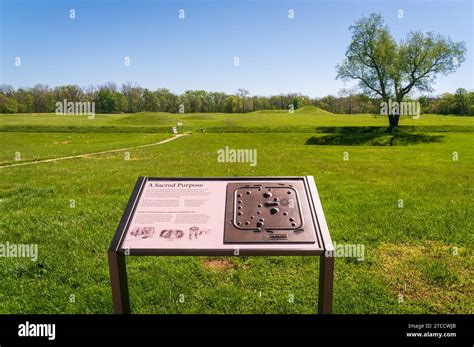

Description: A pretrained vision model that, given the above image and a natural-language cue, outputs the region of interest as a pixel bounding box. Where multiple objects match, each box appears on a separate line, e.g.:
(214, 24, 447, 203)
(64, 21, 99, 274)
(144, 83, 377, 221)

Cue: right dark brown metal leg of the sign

(318, 252, 334, 314)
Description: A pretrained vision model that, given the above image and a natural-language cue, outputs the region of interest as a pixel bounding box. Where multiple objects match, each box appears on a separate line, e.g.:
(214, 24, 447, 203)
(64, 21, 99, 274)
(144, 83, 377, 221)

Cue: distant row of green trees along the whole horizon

(0, 83, 474, 115)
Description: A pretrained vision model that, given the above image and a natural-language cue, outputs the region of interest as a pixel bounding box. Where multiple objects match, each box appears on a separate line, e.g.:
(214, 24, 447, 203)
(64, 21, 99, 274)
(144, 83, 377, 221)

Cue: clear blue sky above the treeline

(0, 0, 474, 97)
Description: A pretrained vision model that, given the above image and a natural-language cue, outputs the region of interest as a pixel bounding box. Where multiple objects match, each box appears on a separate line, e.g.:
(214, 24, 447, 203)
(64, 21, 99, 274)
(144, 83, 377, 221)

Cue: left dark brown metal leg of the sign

(108, 252, 130, 314)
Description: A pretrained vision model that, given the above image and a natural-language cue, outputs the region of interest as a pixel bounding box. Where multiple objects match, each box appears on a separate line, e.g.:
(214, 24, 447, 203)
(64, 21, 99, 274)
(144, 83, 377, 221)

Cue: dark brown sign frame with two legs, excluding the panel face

(108, 176, 334, 314)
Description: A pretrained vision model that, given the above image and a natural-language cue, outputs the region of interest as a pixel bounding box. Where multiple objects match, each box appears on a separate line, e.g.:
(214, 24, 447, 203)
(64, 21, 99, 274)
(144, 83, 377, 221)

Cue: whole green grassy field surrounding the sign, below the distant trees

(0, 108, 474, 313)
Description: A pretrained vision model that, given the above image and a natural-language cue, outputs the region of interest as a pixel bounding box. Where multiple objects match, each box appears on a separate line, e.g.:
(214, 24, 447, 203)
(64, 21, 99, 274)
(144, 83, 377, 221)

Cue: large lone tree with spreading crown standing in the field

(337, 14, 466, 129)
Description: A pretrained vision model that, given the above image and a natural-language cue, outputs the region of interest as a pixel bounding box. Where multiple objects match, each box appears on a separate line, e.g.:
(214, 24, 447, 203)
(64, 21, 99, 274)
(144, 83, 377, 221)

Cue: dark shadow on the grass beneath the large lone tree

(305, 132, 444, 146)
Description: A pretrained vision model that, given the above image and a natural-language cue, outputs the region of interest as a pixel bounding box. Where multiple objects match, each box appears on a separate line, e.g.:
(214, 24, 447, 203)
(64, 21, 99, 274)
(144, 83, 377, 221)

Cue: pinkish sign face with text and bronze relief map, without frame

(120, 178, 321, 250)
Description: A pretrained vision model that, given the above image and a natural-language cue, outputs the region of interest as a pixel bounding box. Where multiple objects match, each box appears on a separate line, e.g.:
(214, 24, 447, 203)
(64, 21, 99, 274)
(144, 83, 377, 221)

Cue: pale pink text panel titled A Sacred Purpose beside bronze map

(123, 181, 226, 248)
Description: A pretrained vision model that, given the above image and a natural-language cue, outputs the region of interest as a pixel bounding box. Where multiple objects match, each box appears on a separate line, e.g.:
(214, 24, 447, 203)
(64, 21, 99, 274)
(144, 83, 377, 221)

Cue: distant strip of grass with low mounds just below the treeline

(0, 108, 474, 132)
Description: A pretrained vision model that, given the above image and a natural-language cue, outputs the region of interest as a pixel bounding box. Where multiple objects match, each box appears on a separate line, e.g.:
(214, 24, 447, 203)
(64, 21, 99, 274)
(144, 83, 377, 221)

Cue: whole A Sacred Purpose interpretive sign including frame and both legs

(109, 176, 334, 313)
